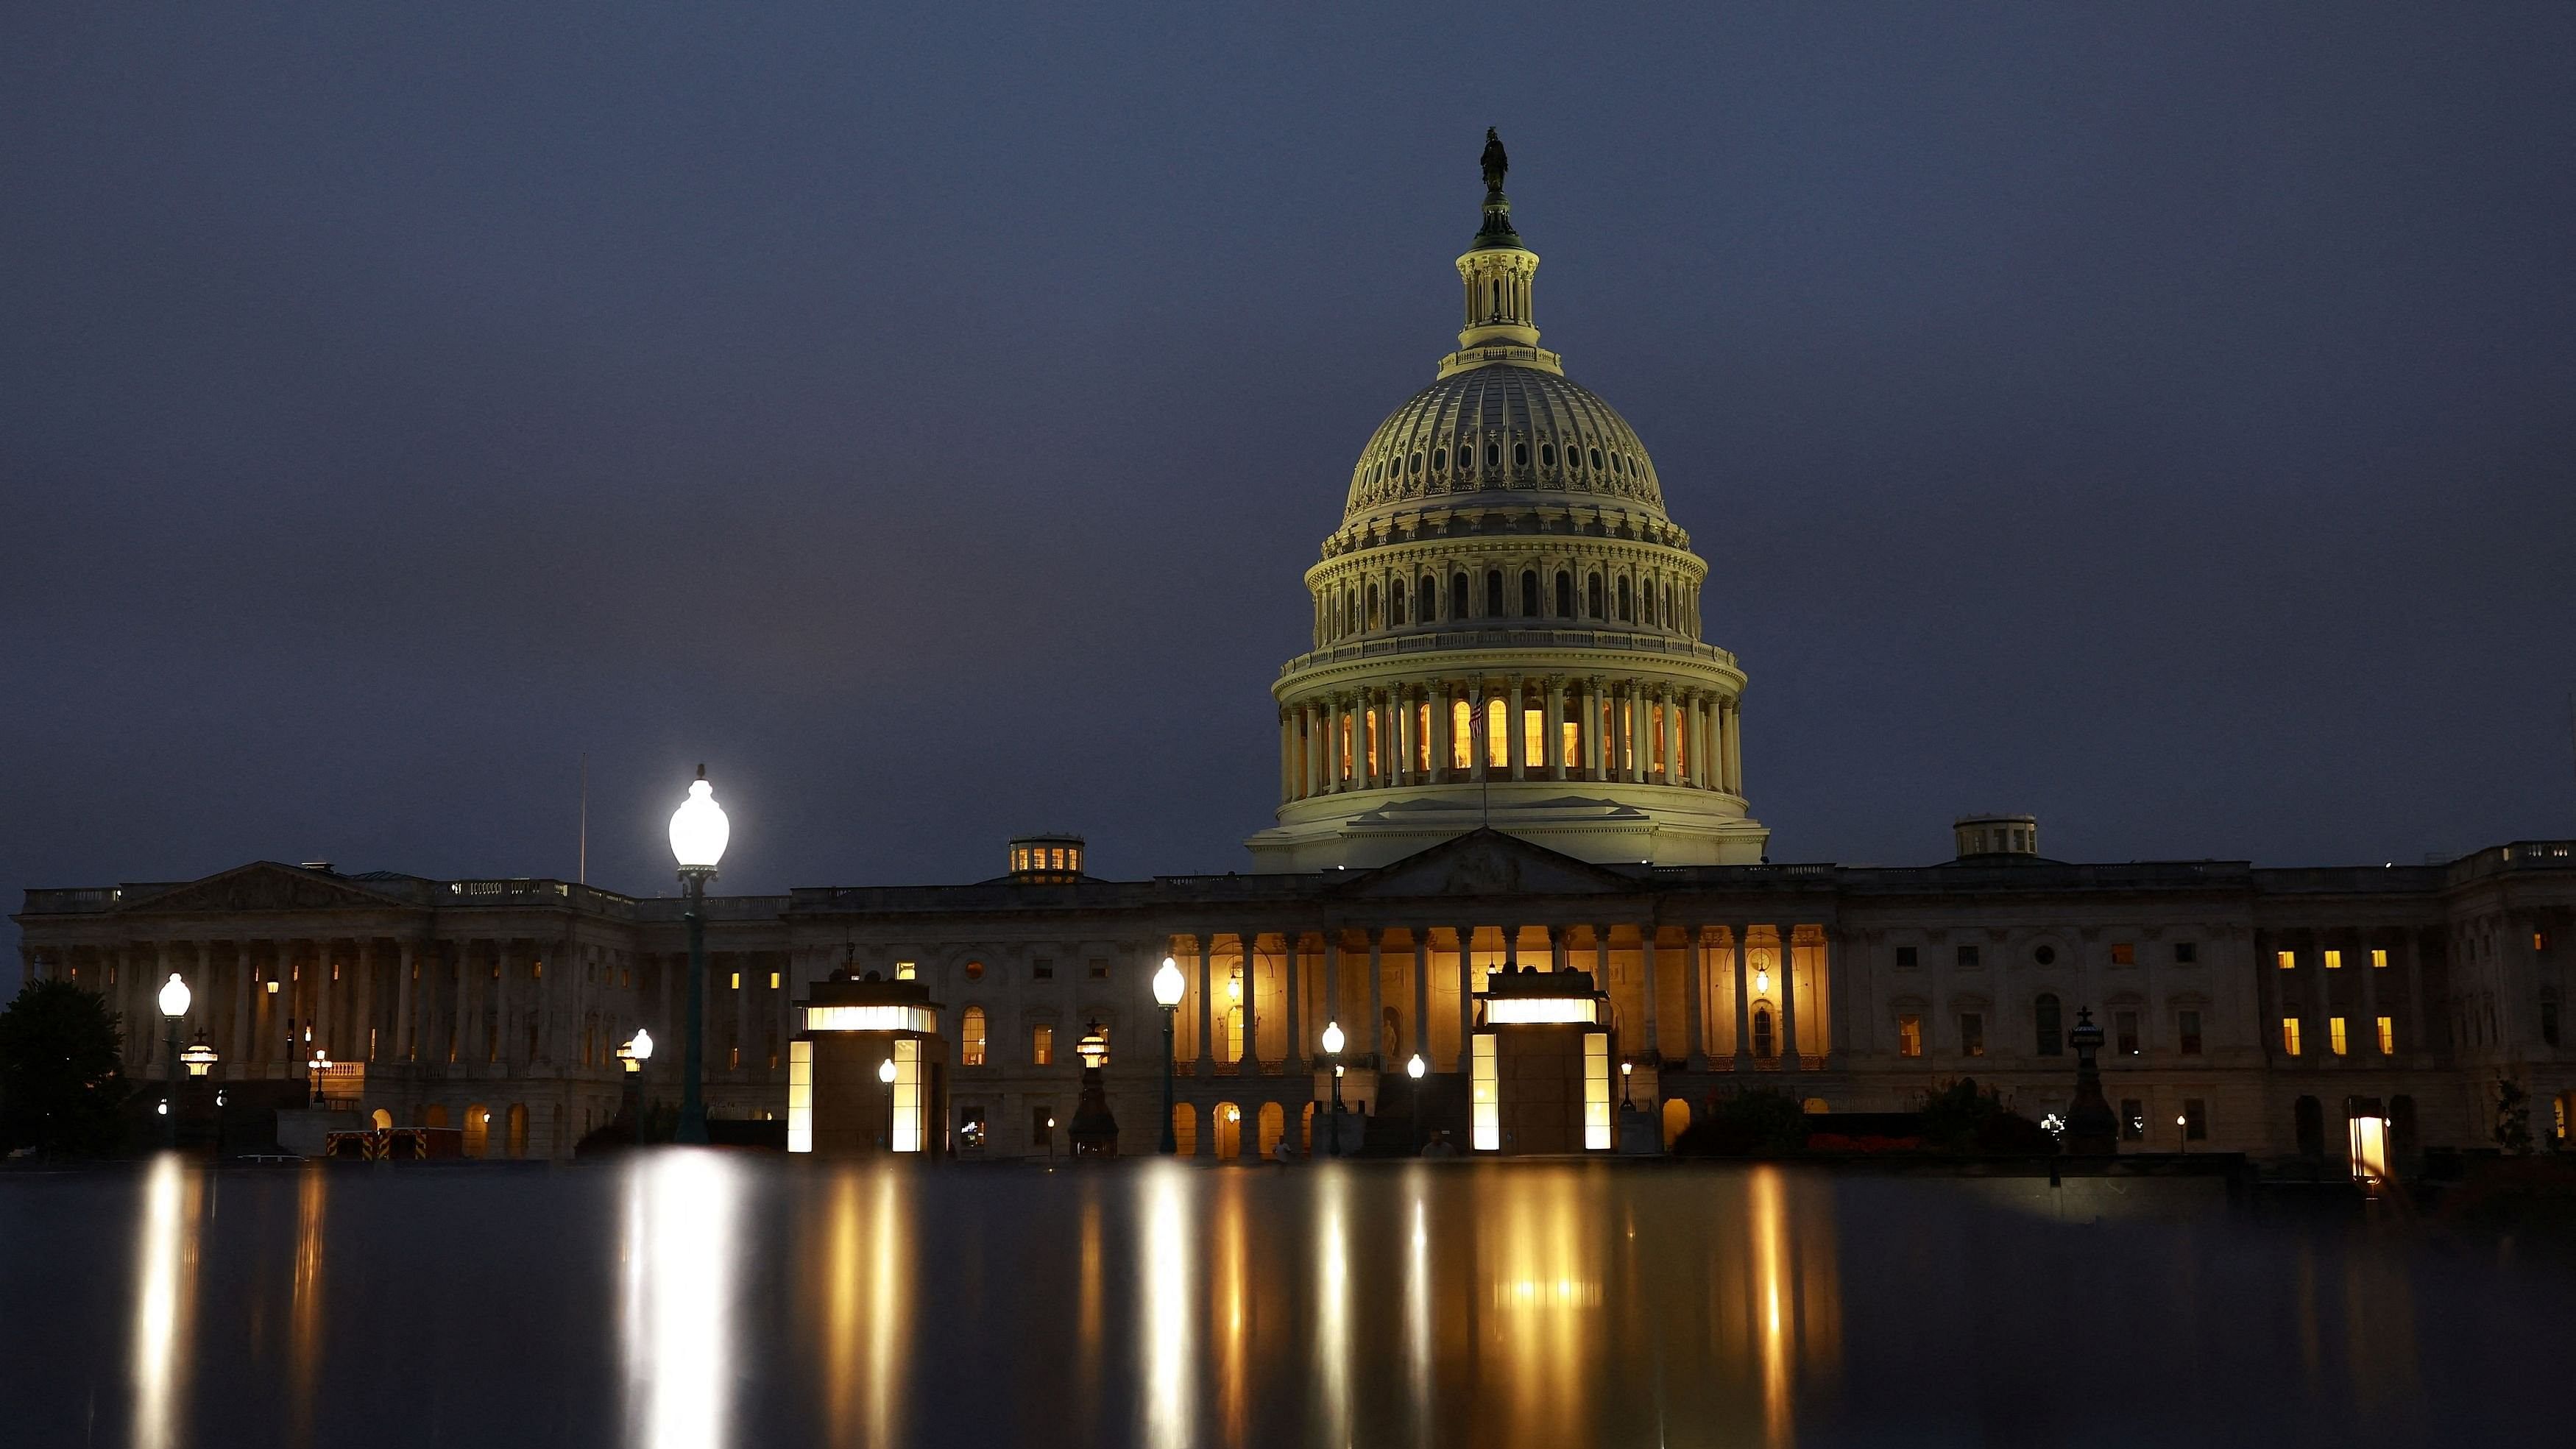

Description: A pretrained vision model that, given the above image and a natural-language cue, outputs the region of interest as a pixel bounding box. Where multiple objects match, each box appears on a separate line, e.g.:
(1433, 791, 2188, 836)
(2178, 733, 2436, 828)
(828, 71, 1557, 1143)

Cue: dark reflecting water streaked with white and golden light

(0, 1150, 2576, 1449)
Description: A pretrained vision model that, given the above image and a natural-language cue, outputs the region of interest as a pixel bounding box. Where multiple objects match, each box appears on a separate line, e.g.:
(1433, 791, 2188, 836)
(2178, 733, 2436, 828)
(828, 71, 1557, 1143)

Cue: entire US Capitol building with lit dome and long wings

(15, 139, 2576, 1158)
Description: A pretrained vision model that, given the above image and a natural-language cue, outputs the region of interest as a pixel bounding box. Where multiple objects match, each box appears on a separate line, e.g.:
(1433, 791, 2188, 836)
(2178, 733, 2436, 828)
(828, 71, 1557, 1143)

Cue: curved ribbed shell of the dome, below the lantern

(1342, 366, 1664, 517)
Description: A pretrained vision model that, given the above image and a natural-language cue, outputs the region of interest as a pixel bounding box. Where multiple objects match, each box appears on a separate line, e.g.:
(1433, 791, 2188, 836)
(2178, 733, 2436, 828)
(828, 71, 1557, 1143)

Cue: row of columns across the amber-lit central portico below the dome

(1175, 924, 1832, 1076)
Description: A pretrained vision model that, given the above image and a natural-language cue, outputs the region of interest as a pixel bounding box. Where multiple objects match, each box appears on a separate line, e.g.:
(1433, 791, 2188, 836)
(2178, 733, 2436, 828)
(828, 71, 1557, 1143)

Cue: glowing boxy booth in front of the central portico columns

(1468, 968, 1610, 1155)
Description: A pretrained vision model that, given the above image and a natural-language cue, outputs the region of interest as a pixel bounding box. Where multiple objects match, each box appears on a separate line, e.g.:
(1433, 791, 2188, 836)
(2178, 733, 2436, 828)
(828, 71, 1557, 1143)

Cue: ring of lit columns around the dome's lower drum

(1281, 674, 1744, 801)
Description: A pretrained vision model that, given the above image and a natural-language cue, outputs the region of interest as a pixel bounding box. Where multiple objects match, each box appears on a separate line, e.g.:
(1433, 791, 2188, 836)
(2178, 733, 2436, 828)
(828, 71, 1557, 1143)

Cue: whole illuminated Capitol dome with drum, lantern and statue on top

(1247, 131, 1770, 870)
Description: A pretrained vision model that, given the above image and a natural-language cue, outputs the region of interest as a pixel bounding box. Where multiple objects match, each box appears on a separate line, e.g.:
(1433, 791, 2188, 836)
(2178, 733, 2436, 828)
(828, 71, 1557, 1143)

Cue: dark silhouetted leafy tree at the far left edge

(0, 980, 132, 1155)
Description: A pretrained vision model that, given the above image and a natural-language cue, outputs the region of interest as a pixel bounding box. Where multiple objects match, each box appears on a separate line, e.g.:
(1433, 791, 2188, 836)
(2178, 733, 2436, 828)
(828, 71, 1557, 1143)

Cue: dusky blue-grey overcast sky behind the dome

(0, 2, 2576, 980)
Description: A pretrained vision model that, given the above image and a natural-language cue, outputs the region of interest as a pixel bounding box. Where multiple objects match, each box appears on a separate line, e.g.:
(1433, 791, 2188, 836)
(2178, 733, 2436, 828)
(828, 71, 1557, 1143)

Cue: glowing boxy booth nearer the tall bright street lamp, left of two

(788, 970, 948, 1155)
